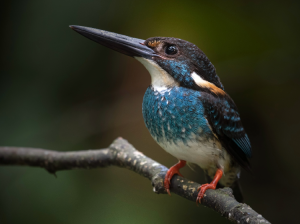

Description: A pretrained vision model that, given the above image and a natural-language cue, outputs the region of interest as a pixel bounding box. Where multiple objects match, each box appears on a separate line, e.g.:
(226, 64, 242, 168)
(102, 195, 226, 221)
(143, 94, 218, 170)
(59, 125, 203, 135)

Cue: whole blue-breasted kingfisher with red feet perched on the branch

(70, 25, 252, 203)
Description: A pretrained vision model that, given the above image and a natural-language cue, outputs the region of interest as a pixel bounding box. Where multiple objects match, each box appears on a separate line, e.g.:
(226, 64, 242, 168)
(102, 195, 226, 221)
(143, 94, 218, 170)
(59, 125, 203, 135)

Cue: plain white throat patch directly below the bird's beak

(134, 57, 178, 92)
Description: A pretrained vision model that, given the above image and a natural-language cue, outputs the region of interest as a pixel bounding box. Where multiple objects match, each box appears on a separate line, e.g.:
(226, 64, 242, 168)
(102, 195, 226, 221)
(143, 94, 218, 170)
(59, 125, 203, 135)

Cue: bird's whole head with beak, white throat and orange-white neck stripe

(70, 26, 224, 94)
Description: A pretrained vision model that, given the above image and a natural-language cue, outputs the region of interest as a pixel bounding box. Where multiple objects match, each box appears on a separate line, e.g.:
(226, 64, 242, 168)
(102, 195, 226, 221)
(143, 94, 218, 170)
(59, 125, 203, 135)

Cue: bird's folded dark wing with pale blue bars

(205, 94, 252, 171)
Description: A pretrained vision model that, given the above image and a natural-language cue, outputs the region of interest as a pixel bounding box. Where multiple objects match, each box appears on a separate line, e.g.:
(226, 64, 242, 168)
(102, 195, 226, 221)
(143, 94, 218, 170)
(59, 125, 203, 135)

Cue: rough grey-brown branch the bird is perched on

(0, 138, 270, 224)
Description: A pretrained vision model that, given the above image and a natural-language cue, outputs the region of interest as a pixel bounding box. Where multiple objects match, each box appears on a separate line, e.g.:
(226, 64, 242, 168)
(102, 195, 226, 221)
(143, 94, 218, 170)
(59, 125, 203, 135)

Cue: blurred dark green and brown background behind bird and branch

(0, 0, 300, 224)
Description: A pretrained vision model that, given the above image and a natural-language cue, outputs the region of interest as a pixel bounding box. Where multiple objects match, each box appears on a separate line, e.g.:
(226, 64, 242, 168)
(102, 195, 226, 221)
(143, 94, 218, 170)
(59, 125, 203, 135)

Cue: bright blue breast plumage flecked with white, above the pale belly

(143, 86, 213, 145)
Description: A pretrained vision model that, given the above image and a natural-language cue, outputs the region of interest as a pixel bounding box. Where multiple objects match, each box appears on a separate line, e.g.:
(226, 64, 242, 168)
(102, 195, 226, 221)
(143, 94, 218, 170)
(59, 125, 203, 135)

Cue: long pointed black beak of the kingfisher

(70, 25, 158, 58)
